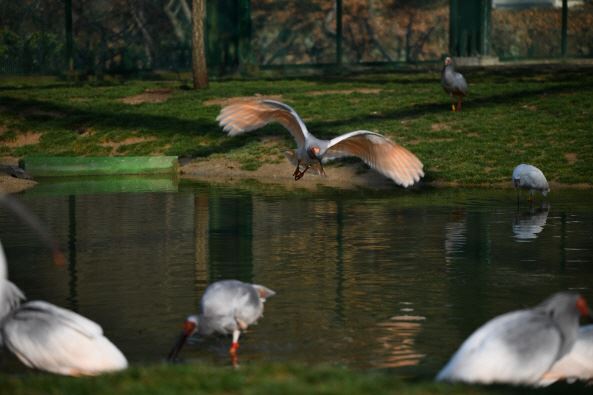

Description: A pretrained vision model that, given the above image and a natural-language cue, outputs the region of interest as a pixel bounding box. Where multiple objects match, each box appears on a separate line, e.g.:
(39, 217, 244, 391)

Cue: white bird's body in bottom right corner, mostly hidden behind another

(541, 325, 593, 384)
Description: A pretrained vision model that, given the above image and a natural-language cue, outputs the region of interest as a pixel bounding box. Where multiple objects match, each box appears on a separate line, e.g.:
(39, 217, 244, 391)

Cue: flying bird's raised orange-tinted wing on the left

(216, 100, 309, 147)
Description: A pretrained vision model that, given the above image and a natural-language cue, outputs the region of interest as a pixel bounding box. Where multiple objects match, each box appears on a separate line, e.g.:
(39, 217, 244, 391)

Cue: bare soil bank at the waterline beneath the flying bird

(180, 158, 398, 190)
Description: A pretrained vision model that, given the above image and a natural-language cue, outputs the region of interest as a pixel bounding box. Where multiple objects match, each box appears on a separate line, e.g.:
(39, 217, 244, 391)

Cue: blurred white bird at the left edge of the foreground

(0, 243, 128, 376)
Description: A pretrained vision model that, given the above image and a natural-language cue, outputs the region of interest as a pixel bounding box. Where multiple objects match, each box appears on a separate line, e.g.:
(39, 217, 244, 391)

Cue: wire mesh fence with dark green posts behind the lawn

(0, 0, 593, 76)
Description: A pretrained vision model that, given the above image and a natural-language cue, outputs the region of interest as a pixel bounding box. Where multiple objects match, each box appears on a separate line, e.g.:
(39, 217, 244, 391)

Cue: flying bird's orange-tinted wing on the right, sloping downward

(326, 130, 424, 187)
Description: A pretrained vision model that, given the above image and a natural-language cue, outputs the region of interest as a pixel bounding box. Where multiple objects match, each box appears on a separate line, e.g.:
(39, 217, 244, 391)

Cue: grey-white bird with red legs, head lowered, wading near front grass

(169, 280, 275, 365)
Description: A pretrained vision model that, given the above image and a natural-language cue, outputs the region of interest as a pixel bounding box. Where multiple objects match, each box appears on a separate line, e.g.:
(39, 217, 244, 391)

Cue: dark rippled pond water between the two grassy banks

(0, 179, 593, 377)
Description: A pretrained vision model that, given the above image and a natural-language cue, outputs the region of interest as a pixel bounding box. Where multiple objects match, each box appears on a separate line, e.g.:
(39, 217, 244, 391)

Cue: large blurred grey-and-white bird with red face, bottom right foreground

(437, 292, 591, 384)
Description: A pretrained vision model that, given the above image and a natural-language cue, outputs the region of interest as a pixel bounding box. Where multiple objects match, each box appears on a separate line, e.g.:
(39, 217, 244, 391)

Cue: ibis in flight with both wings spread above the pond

(216, 100, 424, 187)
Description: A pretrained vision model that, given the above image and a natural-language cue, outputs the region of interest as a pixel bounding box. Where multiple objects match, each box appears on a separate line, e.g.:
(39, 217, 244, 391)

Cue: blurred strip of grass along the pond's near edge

(0, 364, 591, 395)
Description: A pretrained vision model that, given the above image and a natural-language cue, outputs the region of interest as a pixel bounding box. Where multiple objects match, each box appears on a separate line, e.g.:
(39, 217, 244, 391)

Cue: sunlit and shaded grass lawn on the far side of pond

(0, 66, 593, 184)
